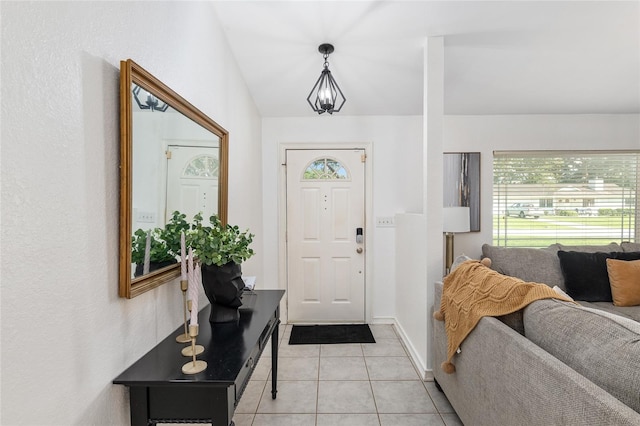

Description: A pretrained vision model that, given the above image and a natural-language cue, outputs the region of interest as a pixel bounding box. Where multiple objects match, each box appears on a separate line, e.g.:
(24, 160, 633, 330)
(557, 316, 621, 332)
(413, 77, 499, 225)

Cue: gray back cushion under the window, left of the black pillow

(482, 244, 565, 290)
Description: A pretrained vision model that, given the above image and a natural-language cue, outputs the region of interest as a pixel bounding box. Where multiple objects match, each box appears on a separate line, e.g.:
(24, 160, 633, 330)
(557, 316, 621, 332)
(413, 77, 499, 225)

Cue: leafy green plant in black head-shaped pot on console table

(188, 214, 254, 322)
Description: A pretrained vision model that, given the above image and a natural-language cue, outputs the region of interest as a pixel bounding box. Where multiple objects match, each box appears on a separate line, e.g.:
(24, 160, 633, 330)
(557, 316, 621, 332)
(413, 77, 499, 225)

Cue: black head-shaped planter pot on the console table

(201, 262, 245, 322)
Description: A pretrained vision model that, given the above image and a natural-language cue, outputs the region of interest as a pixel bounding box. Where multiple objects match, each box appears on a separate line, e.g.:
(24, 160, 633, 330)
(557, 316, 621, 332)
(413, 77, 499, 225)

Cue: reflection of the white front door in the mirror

(165, 145, 219, 223)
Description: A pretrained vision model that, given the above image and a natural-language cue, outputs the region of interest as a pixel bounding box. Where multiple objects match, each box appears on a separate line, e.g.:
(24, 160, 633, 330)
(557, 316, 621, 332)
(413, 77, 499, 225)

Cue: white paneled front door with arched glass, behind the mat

(286, 149, 366, 323)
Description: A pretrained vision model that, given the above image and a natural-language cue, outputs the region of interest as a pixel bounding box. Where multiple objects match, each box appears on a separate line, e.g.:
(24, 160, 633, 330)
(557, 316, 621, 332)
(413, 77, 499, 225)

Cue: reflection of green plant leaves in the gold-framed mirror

(131, 211, 189, 277)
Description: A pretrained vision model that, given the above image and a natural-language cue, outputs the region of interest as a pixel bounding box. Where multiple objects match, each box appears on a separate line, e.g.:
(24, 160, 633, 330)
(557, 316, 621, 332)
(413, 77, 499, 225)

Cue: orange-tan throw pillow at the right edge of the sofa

(607, 259, 640, 306)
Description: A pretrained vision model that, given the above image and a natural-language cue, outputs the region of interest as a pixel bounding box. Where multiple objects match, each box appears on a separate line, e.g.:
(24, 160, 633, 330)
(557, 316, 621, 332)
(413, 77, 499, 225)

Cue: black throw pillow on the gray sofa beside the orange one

(558, 250, 640, 302)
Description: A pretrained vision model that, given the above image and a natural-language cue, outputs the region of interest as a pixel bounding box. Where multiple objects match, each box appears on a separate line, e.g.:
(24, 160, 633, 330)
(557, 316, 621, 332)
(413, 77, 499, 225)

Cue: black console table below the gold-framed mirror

(113, 290, 284, 426)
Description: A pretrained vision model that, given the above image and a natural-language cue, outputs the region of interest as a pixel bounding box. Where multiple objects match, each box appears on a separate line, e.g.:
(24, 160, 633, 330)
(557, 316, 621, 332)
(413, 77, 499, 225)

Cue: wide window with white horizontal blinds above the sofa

(493, 151, 640, 247)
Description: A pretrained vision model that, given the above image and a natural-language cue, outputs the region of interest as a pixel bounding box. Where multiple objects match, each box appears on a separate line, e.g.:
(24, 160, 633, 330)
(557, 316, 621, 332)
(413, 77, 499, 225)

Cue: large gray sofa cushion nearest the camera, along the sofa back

(523, 299, 640, 412)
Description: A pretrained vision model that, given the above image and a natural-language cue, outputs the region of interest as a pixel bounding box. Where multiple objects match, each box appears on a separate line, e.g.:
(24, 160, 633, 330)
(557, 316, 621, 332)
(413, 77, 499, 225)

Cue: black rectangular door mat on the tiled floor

(289, 324, 376, 345)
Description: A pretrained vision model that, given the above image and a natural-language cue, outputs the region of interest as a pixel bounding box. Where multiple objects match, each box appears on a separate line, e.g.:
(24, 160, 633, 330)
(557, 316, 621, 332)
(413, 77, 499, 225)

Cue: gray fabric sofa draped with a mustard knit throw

(433, 244, 640, 426)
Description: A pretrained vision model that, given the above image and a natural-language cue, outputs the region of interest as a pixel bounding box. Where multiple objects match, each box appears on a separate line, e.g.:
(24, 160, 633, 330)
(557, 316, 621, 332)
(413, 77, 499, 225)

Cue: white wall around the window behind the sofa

(444, 114, 640, 258)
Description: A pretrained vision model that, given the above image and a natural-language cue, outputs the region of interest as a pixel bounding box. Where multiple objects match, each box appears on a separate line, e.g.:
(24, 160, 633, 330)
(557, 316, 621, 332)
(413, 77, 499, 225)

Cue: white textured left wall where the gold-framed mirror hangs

(0, 1, 262, 425)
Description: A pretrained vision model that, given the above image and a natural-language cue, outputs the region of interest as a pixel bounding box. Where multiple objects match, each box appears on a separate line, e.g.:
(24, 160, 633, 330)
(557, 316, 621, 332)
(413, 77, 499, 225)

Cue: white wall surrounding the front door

(262, 115, 422, 321)
